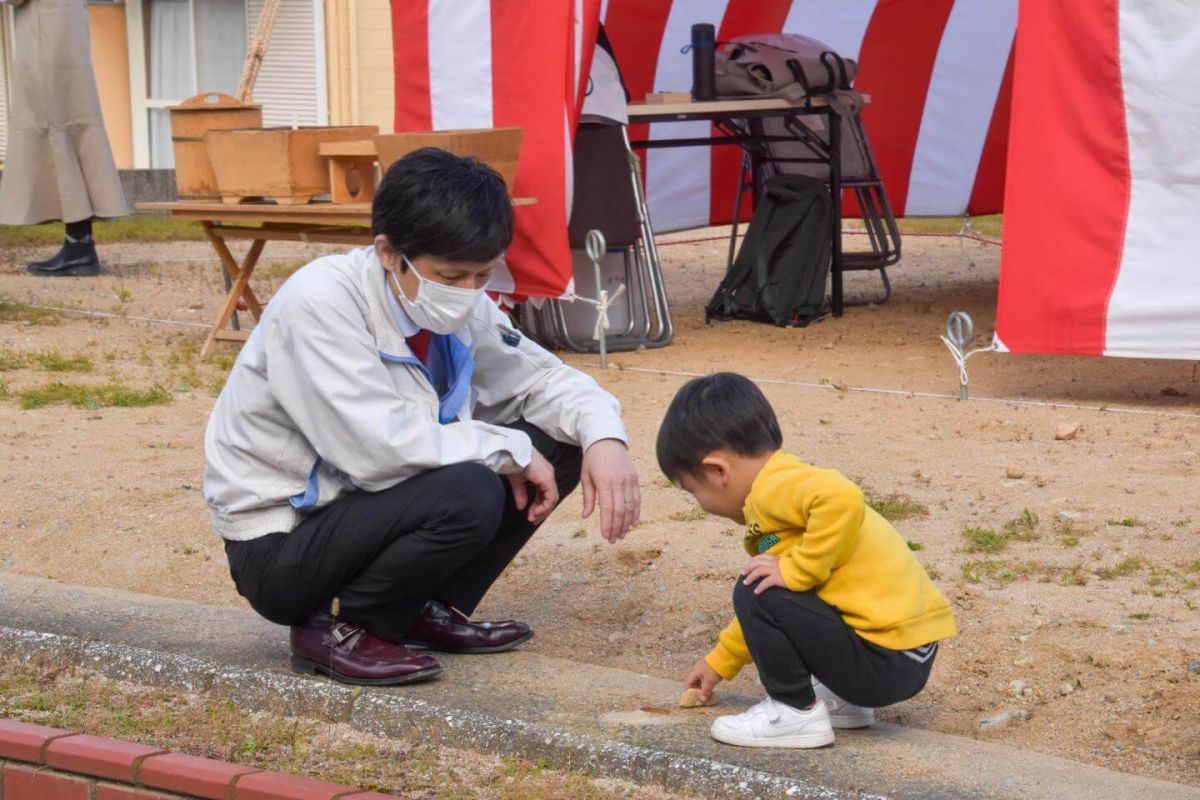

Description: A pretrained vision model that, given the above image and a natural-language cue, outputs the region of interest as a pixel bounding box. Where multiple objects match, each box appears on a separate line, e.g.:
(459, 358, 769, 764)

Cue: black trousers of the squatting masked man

(226, 421, 582, 642)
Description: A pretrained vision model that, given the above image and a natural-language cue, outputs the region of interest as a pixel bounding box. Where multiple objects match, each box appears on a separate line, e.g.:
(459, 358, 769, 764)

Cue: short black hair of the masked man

(371, 148, 512, 261)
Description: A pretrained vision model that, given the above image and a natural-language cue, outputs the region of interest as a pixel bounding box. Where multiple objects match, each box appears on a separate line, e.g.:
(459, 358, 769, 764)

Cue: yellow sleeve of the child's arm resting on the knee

(773, 470, 866, 591)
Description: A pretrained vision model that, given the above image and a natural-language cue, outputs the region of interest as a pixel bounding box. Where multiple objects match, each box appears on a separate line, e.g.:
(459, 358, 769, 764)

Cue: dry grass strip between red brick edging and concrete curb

(0, 656, 671, 800)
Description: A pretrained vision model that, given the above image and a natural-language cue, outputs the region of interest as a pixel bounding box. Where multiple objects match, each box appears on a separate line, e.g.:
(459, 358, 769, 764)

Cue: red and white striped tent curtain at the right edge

(996, 0, 1200, 360)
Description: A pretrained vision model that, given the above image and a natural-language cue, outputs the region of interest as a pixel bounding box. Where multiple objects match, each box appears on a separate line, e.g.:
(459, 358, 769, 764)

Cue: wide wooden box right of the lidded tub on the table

(208, 125, 379, 205)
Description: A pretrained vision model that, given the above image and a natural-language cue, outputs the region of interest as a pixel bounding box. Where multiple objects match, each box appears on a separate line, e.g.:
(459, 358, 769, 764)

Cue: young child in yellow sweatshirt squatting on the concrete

(658, 373, 956, 747)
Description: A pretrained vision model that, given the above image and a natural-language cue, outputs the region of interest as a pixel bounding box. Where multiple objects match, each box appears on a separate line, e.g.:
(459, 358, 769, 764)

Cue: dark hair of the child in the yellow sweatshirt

(656, 372, 784, 481)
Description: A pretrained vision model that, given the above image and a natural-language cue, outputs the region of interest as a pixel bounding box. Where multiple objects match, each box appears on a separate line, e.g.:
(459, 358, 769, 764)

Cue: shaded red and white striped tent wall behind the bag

(601, 0, 1016, 231)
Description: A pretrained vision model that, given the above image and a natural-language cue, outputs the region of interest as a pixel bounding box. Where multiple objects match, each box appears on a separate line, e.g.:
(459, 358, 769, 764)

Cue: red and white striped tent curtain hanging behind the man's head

(391, 0, 600, 297)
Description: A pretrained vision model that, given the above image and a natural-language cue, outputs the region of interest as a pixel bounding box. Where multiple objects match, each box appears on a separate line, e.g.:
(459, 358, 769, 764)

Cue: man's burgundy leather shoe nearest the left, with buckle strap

(292, 614, 442, 686)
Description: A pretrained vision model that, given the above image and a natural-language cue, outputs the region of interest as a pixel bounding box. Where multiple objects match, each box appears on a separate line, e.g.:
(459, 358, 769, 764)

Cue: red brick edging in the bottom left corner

(0, 718, 402, 800)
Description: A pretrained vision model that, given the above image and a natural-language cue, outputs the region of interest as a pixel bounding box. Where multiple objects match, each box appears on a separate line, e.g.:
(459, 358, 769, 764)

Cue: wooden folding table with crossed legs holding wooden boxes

(137, 197, 536, 359)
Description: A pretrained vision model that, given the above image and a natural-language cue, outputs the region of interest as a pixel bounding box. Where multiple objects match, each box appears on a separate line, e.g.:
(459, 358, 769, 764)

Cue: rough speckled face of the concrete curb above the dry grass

(0, 626, 886, 800)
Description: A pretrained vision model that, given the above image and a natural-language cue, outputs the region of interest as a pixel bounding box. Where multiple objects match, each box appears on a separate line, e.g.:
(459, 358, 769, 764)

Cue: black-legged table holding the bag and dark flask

(628, 95, 870, 317)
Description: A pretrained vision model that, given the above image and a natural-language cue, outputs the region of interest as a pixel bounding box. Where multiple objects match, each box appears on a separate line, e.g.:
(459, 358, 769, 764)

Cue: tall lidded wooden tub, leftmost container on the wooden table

(169, 92, 263, 200)
